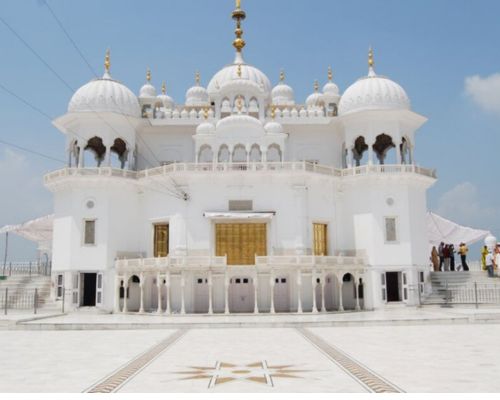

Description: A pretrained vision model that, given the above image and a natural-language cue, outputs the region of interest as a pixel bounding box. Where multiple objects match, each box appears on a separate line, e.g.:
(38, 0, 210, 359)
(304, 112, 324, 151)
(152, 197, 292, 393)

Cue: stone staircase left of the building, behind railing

(0, 275, 55, 309)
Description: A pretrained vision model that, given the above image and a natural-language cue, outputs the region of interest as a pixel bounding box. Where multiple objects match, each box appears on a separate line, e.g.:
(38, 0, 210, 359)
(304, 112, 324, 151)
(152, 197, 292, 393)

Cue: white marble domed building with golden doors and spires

(45, 1, 435, 314)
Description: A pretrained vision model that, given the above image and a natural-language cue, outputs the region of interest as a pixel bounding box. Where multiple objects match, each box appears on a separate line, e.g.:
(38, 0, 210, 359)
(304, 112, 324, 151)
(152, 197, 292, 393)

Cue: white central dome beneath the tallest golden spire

(207, 53, 271, 97)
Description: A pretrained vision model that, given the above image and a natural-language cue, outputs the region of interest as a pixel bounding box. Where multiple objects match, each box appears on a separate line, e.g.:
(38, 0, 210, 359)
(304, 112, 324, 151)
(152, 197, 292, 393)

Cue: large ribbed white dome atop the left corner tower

(68, 71, 141, 118)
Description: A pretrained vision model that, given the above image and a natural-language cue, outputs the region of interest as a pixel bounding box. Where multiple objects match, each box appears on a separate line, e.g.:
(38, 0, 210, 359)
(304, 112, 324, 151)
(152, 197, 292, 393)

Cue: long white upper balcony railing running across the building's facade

(44, 161, 436, 183)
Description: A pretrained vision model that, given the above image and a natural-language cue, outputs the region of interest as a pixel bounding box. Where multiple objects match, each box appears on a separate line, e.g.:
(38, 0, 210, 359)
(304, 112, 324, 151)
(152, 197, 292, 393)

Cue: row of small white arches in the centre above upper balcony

(196, 143, 283, 163)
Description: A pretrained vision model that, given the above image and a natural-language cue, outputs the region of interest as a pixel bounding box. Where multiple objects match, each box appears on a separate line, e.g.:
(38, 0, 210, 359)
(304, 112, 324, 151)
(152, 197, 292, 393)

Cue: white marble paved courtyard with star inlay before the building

(0, 323, 500, 393)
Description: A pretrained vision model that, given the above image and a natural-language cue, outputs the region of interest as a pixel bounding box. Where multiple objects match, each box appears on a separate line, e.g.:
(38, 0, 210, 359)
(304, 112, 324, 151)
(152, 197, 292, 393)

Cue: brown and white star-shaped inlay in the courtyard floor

(176, 360, 308, 389)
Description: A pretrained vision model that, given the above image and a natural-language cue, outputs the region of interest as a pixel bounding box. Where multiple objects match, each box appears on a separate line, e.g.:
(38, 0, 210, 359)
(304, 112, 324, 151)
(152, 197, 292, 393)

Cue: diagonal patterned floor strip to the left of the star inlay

(85, 329, 188, 393)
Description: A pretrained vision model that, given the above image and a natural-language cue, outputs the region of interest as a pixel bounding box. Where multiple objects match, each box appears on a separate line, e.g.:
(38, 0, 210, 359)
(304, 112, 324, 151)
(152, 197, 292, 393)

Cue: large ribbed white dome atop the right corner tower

(339, 67, 410, 115)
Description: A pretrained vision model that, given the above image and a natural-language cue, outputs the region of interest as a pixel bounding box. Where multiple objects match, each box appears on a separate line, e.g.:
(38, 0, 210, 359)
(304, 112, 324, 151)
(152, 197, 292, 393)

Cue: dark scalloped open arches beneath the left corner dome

(68, 136, 135, 169)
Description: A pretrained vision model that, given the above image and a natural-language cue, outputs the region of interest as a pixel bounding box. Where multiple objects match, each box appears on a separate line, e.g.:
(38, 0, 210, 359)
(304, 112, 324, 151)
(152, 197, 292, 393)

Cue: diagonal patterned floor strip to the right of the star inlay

(296, 328, 403, 393)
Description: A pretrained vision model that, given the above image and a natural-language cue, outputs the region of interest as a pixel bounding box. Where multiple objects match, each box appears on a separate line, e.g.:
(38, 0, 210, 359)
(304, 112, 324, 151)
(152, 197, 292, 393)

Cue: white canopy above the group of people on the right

(427, 211, 490, 246)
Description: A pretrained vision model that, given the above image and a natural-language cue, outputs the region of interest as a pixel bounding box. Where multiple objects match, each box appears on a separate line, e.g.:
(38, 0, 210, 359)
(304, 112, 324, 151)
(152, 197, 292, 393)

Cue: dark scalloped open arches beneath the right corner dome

(342, 133, 413, 168)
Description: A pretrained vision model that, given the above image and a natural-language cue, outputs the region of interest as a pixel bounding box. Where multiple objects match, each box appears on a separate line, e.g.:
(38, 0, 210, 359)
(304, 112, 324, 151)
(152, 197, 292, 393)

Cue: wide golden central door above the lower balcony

(215, 224, 267, 265)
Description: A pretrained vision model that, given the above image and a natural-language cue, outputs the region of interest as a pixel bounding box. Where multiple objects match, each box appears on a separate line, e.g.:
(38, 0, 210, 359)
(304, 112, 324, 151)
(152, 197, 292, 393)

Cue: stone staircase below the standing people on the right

(422, 271, 500, 305)
